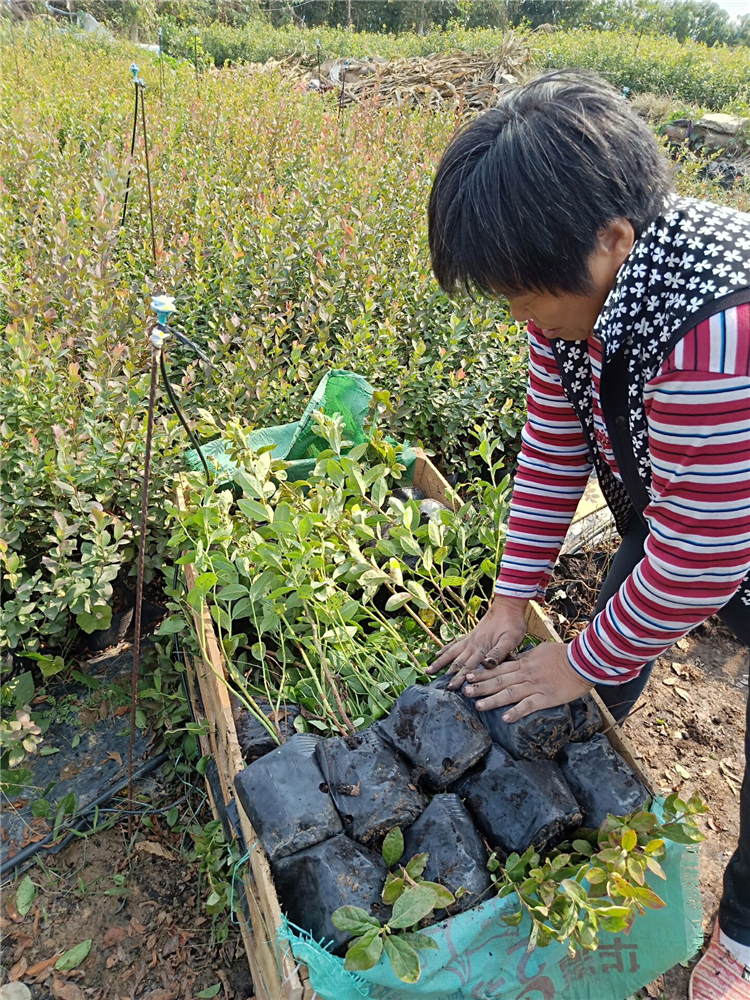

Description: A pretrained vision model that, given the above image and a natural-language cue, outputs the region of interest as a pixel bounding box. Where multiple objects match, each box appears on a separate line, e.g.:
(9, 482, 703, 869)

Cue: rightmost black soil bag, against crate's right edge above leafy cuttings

(558, 736, 649, 829)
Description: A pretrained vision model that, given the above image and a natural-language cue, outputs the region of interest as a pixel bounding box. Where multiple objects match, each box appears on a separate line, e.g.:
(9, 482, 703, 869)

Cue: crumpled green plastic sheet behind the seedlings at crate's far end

(185, 368, 415, 482)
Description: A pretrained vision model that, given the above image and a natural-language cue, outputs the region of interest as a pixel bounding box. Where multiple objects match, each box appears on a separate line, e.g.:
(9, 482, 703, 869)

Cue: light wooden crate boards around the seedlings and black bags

(178, 450, 656, 1000)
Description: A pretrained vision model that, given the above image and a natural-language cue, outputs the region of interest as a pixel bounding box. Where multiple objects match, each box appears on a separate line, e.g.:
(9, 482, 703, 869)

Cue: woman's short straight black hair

(429, 70, 672, 295)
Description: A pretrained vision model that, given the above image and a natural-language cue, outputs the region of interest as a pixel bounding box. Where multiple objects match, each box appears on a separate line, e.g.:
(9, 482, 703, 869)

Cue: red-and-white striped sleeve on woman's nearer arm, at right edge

(568, 305, 750, 684)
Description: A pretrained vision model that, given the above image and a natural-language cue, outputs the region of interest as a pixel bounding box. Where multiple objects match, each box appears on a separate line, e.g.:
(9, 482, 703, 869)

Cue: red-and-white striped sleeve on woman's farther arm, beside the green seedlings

(495, 323, 591, 599)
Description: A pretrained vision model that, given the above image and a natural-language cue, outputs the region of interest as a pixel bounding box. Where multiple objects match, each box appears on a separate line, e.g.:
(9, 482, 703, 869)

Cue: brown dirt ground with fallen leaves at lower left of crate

(0, 817, 253, 1000)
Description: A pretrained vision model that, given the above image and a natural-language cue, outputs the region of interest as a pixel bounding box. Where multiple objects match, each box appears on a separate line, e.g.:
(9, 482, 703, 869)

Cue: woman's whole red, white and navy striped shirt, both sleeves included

(495, 304, 750, 684)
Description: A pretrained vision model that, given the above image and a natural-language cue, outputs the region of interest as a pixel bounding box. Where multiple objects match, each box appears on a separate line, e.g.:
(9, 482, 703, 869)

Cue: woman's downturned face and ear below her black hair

(508, 219, 635, 340)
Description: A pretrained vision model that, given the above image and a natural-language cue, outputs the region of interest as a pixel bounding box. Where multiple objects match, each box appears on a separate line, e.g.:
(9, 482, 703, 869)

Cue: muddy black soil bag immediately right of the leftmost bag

(316, 729, 427, 844)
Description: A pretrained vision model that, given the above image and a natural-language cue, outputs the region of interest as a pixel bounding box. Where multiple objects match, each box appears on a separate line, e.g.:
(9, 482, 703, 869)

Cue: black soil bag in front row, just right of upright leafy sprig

(404, 792, 492, 916)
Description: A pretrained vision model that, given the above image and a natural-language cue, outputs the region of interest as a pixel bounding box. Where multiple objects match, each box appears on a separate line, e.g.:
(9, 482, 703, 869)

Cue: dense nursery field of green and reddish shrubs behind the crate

(0, 17, 748, 657)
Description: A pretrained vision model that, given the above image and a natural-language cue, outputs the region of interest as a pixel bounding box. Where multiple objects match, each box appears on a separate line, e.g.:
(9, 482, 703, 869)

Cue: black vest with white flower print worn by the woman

(551, 197, 750, 604)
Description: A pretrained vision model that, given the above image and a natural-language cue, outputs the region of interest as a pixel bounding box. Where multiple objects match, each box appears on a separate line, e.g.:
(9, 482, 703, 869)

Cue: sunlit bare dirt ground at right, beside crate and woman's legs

(548, 553, 750, 1000)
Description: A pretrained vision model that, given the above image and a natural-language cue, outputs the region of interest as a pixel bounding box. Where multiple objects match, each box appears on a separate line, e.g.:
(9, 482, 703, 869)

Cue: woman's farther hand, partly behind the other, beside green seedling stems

(427, 595, 529, 691)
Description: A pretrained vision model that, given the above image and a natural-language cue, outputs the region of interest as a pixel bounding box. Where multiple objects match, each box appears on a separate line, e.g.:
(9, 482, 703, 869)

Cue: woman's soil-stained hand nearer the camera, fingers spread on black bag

(462, 642, 594, 722)
